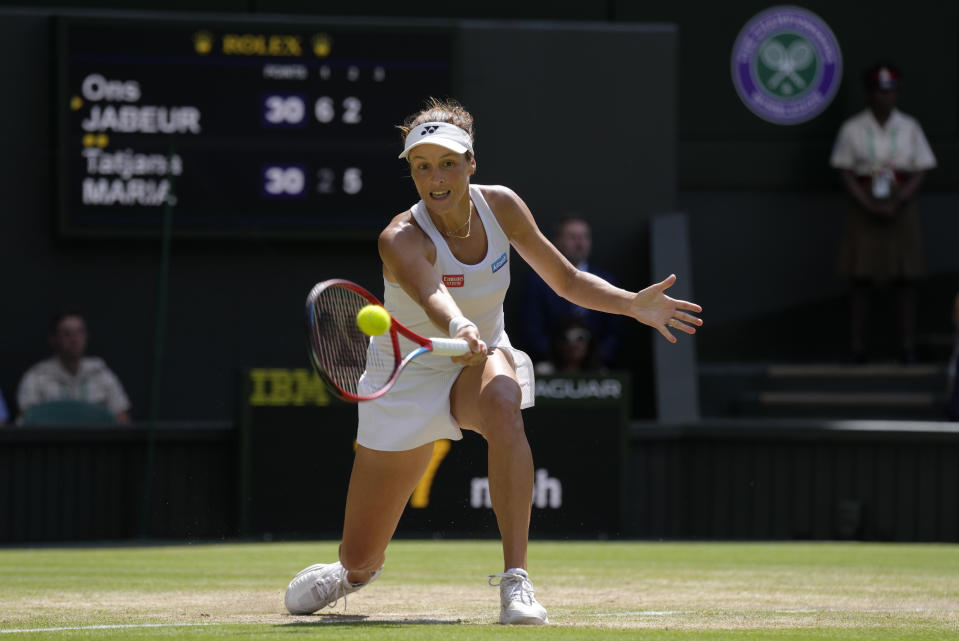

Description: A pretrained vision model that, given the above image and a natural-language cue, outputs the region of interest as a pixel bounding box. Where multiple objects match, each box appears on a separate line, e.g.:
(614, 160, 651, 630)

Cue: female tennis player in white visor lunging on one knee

(285, 99, 702, 624)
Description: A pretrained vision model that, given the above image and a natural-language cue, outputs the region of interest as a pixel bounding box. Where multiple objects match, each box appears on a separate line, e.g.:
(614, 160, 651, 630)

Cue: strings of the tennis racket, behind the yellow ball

(310, 286, 395, 395)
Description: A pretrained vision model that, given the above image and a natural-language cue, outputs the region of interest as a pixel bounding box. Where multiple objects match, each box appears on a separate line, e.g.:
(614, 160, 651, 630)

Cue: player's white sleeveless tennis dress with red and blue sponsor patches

(357, 185, 535, 451)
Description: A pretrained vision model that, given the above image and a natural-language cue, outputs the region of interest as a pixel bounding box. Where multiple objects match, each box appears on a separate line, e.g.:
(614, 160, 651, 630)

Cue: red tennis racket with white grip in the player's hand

(306, 279, 470, 403)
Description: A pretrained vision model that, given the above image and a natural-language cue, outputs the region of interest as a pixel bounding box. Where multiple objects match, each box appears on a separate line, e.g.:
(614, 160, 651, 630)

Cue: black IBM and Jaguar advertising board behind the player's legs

(239, 369, 630, 538)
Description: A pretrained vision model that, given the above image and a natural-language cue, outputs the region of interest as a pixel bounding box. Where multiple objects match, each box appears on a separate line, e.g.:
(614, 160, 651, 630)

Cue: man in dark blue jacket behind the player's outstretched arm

(520, 216, 623, 367)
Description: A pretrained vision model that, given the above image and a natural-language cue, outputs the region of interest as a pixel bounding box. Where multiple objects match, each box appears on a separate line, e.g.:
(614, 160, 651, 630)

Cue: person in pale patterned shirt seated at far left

(17, 313, 130, 423)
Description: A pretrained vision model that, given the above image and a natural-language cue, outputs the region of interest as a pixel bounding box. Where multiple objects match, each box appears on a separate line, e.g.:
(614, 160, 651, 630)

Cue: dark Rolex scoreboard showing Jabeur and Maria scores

(57, 16, 453, 238)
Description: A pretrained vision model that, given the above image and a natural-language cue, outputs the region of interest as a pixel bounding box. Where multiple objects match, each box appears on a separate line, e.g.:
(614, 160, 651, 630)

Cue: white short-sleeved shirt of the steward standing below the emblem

(829, 109, 936, 176)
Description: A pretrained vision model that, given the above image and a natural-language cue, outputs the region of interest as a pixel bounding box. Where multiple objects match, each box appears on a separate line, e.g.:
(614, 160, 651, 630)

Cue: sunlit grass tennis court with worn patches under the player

(0, 541, 959, 641)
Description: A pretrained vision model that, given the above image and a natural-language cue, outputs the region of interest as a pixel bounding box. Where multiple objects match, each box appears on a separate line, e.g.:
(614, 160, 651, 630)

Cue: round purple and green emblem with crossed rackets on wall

(732, 7, 842, 125)
